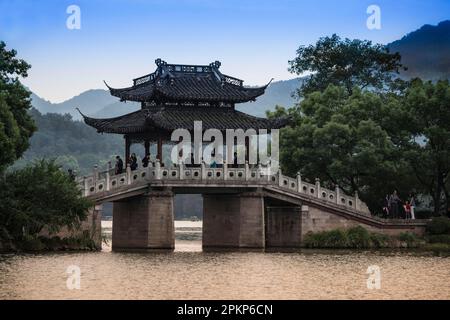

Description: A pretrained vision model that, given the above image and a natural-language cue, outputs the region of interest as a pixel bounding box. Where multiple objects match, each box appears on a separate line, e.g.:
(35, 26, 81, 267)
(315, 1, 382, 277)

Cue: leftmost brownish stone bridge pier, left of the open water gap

(112, 191, 175, 250)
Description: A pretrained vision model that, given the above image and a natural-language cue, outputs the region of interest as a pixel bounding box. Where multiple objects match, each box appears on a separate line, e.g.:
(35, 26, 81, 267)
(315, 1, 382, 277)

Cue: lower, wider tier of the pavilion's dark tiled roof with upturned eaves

(80, 106, 287, 134)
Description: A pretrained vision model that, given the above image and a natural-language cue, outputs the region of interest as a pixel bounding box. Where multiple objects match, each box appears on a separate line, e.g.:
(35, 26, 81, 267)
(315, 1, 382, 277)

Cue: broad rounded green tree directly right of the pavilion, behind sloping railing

(269, 85, 414, 212)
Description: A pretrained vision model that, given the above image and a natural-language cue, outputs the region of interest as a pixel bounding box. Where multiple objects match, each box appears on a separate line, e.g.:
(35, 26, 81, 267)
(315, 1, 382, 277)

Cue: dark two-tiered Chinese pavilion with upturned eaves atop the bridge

(80, 59, 286, 165)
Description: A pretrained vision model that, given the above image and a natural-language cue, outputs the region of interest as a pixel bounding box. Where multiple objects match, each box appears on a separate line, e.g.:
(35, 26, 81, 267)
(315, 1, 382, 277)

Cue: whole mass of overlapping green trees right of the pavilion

(269, 35, 450, 215)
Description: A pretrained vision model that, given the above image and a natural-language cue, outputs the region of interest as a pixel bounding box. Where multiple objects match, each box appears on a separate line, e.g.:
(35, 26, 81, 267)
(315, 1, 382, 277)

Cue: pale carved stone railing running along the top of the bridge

(77, 160, 370, 215)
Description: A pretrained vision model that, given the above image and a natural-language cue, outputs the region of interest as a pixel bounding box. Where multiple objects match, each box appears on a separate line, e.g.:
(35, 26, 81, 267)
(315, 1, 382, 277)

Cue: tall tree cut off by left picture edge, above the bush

(0, 42, 36, 172)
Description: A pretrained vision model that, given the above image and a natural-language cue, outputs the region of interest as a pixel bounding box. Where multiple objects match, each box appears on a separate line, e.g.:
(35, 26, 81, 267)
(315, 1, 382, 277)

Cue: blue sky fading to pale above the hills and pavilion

(0, 0, 450, 102)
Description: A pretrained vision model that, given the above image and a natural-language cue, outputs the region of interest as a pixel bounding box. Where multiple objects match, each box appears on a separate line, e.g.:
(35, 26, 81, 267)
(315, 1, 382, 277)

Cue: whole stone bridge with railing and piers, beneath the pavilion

(77, 161, 425, 250)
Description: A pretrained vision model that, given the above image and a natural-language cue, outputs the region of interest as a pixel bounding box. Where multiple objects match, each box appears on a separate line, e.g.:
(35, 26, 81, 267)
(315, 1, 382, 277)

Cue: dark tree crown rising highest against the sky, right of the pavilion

(289, 34, 402, 96)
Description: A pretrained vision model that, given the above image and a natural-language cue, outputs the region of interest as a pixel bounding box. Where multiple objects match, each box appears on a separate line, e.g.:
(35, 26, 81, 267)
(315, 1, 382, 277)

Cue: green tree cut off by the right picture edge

(404, 79, 450, 214)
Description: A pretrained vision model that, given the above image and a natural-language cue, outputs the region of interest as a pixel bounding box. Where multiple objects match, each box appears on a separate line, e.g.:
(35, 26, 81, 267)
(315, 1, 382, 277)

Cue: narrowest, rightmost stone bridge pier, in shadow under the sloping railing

(266, 207, 302, 248)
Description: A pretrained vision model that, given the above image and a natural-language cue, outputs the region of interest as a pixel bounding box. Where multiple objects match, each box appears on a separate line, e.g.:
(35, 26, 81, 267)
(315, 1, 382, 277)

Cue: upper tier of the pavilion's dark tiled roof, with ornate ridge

(105, 59, 270, 103)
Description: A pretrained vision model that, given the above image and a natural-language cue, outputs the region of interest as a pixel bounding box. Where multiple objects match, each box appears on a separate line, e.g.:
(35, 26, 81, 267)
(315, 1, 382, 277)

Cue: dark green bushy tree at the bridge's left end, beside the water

(0, 160, 93, 240)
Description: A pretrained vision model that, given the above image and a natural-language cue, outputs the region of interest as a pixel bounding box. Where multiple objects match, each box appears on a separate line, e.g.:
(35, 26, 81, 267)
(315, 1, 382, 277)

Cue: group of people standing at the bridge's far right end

(383, 190, 416, 219)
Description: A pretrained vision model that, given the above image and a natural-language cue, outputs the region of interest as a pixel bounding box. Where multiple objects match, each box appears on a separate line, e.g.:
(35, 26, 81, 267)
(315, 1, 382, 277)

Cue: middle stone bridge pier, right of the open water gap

(202, 192, 265, 248)
